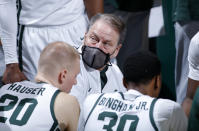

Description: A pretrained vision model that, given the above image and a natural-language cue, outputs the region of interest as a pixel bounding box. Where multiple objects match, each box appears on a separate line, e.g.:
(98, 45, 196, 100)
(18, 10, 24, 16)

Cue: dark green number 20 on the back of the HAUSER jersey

(0, 94, 38, 126)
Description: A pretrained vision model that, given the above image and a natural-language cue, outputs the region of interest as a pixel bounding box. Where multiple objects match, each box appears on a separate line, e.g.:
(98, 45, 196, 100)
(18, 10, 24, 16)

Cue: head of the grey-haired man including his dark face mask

(83, 14, 124, 69)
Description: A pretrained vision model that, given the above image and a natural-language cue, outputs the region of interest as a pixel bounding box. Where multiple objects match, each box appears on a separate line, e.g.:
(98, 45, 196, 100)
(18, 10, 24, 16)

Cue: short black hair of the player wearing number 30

(123, 51, 161, 86)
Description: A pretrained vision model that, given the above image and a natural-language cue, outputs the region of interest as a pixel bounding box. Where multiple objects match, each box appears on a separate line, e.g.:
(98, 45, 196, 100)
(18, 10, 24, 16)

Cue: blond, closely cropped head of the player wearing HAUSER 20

(36, 42, 80, 93)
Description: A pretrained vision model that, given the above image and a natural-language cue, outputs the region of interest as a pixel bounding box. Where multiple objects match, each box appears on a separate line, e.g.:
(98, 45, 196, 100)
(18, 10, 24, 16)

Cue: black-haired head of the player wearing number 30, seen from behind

(123, 51, 161, 97)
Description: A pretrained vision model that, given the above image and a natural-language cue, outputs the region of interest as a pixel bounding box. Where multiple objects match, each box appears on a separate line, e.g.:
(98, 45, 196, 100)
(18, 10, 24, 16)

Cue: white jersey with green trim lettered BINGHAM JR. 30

(79, 90, 187, 131)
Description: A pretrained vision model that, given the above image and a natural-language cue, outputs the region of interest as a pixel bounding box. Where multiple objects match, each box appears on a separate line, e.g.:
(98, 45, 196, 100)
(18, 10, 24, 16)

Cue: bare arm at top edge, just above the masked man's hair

(84, 0, 104, 19)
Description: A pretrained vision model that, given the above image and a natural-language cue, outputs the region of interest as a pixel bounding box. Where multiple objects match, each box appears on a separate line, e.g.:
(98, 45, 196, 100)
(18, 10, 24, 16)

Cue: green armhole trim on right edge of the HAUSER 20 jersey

(50, 90, 60, 131)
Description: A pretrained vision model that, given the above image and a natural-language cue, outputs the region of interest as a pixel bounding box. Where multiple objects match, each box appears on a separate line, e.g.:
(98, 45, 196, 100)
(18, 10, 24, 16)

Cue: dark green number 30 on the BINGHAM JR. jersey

(98, 111, 139, 131)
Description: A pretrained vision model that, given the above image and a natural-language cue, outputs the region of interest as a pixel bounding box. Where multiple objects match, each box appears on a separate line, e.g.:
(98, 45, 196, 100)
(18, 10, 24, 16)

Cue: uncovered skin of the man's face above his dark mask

(84, 20, 121, 58)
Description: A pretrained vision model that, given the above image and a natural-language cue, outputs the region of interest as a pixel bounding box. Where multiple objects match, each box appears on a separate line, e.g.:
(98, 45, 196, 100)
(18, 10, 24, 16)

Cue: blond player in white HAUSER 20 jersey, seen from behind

(0, 42, 80, 131)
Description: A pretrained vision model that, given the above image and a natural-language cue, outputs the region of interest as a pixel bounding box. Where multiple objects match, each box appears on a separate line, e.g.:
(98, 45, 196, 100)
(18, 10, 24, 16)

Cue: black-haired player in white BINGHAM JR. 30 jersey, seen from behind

(83, 51, 187, 131)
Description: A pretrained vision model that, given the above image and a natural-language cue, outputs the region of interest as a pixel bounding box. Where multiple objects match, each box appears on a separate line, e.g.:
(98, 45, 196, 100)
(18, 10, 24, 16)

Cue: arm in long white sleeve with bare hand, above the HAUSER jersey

(0, 0, 26, 84)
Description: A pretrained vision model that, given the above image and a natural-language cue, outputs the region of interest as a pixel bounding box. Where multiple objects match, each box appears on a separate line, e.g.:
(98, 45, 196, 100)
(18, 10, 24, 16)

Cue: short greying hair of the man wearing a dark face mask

(88, 13, 125, 43)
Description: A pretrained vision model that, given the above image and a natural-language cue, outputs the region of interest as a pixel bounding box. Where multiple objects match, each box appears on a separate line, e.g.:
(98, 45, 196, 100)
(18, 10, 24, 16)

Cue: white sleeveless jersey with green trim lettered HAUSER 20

(0, 81, 59, 131)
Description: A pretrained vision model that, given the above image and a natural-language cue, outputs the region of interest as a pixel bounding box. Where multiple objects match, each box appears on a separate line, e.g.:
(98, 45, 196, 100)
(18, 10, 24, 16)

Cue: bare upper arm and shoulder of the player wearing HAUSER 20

(54, 92, 80, 131)
